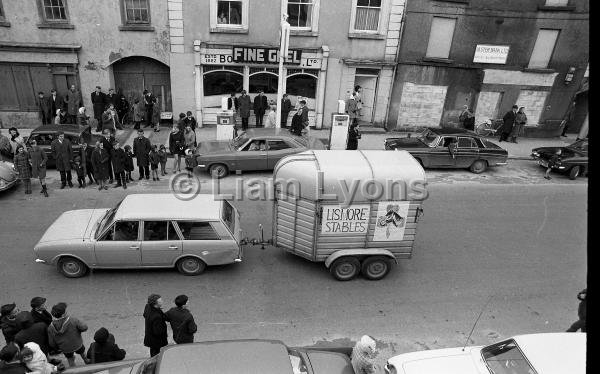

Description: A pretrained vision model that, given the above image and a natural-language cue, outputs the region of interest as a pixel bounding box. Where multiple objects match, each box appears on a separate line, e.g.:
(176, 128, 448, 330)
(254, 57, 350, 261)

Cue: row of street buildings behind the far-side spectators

(0, 0, 589, 136)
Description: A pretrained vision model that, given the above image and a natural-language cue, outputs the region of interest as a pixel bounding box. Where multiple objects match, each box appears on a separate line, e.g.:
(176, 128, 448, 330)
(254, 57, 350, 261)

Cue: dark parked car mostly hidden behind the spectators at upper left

(26, 125, 102, 167)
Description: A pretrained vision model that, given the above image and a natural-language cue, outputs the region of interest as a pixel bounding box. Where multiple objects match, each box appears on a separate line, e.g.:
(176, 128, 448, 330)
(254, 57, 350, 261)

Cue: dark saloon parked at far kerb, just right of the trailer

(385, 128, 508, 174)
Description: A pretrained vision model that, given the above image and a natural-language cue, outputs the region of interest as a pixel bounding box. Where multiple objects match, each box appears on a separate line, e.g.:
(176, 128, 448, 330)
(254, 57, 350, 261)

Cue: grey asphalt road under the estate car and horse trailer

(0, 180, 587, 366)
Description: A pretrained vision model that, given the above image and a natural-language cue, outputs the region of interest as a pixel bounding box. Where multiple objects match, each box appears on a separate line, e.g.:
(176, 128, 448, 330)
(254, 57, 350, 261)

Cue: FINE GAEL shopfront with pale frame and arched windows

(194, 41, 327, 128)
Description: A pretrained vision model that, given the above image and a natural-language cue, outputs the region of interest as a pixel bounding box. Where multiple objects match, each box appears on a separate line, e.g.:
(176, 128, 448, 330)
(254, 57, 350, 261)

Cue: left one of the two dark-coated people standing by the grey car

(144, 294, 169, 357)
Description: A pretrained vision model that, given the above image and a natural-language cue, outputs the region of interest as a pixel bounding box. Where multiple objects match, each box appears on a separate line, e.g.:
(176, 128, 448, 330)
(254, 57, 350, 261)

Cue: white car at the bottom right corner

(385, 332, 586, 374)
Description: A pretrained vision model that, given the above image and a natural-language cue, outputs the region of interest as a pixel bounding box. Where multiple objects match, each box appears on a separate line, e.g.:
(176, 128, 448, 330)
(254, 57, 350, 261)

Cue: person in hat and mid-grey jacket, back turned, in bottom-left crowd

(48, 303, 89, 367)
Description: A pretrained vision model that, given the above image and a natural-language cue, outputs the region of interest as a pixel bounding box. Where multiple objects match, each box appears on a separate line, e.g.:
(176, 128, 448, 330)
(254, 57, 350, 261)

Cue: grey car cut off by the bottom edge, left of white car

(63, 339, 355, 374)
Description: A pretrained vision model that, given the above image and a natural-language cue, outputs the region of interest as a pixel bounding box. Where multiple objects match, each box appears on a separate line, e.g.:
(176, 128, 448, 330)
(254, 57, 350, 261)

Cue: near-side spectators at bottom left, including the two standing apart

(0, 294, 198, 374)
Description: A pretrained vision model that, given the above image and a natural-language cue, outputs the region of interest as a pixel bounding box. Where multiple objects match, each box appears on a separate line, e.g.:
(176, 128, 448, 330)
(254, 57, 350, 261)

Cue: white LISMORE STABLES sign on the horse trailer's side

(321, 204, 371, 235)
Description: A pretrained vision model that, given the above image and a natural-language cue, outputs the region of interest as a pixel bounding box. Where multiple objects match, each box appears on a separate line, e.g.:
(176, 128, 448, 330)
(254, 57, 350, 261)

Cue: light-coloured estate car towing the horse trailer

(34, 194, 243, 278)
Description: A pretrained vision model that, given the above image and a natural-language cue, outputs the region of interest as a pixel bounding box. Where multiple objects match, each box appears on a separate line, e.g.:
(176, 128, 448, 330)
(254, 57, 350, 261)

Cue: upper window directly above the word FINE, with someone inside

(210, 0, 249, 33)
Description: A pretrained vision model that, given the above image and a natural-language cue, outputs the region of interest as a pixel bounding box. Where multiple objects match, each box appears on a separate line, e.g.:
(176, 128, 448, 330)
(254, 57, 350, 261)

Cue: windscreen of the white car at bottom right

(481, 339, 537, 374)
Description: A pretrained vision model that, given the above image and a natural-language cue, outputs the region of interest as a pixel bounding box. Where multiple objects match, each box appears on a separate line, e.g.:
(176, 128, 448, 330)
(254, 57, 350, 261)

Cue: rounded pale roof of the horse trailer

(273, 150, 426, 203)
